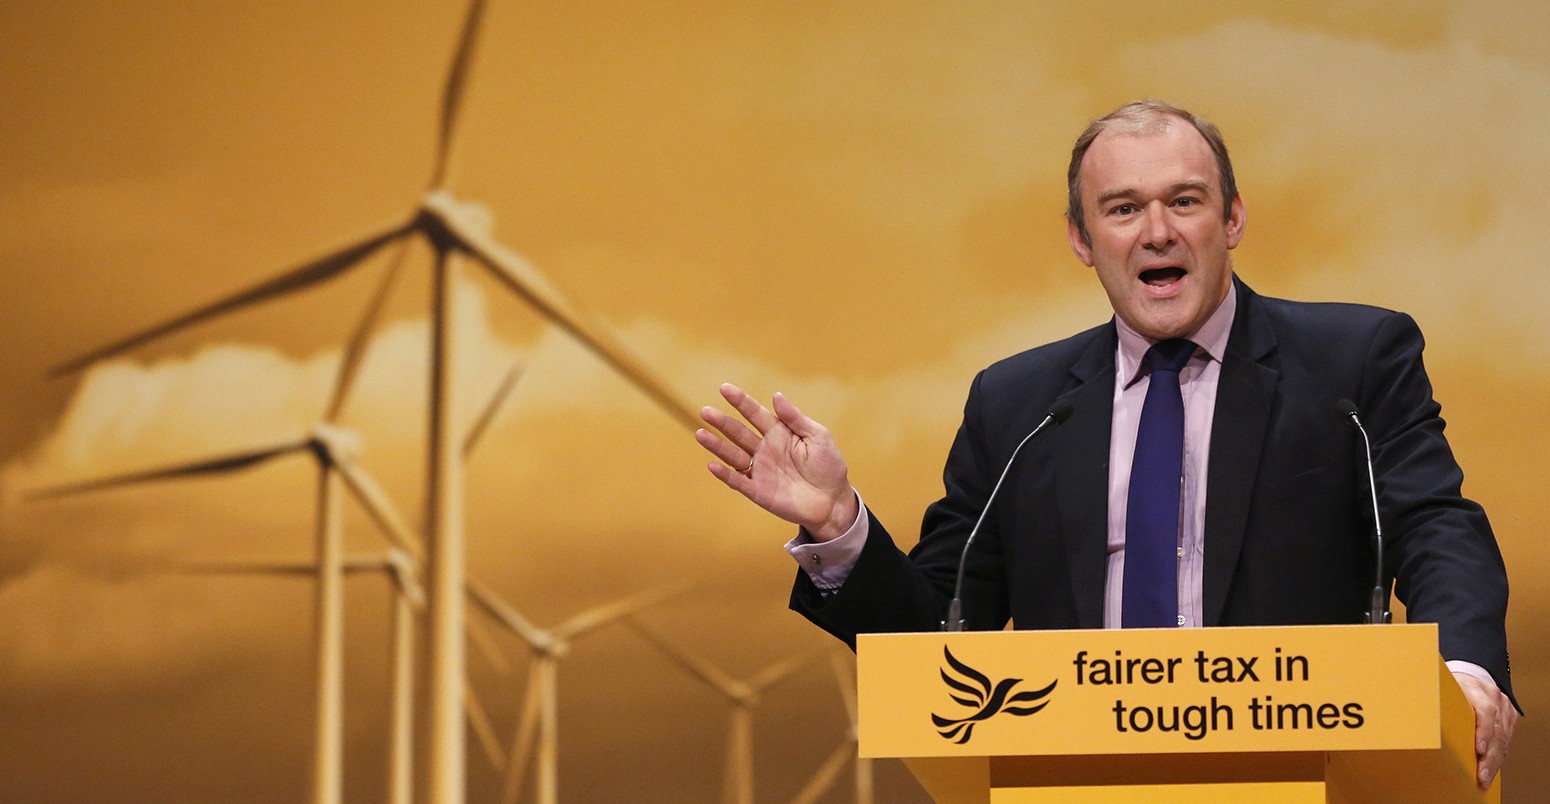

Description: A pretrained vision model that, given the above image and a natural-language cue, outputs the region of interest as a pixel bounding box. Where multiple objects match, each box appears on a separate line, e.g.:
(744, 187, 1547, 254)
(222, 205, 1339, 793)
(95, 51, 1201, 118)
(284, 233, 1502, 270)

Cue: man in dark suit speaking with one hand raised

(698, 102, 1517, 787)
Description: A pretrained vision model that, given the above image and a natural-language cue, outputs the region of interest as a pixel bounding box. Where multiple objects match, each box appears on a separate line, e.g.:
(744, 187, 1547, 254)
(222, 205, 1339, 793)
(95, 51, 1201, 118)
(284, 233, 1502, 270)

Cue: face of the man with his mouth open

(1068, 121, 1246, 341)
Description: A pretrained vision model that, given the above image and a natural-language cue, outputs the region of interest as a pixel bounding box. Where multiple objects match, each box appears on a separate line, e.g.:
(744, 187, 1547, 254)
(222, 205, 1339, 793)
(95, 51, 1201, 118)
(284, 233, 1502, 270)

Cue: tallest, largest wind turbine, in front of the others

(43, 0, 699, 804)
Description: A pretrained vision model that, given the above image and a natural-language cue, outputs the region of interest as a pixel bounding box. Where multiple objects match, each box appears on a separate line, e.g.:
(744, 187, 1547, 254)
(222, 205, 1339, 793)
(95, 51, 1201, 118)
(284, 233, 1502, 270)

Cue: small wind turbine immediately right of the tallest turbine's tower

(468, 578, 688, 804)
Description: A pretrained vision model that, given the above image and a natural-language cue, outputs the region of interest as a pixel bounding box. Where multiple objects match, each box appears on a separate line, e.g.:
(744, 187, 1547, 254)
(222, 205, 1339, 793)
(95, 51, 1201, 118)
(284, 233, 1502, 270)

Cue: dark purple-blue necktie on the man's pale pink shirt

(1121, 338, 1195, 627)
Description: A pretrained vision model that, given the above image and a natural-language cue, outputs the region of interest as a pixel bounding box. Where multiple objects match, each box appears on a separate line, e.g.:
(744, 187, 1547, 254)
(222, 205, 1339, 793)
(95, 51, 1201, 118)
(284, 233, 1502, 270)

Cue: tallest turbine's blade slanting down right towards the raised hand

(429, 198, 701, 429)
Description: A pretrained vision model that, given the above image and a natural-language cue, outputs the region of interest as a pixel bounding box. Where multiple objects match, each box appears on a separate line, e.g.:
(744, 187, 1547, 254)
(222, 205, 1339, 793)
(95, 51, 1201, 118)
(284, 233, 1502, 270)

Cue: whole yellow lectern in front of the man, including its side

(857, 624, 1500, 804)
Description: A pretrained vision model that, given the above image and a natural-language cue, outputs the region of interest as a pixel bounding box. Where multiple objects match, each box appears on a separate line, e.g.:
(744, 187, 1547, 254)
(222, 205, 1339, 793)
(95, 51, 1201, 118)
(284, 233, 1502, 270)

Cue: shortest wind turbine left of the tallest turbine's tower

(171, 547, 425, 804)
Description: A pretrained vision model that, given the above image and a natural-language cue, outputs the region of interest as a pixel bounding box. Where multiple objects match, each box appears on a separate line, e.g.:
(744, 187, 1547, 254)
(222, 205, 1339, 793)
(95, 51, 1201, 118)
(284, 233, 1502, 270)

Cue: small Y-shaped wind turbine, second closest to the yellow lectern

(628, 617, 814, 804)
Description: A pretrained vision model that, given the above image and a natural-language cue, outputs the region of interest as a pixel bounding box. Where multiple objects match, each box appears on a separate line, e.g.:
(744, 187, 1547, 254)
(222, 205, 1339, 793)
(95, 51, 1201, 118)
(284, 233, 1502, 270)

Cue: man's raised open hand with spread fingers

(694, 383, 859, 542)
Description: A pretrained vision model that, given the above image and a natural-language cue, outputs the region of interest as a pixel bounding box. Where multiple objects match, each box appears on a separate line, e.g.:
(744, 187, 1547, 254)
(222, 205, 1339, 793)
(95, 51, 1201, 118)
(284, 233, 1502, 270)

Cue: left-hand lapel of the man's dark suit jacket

(1051, 324, 1116, 627)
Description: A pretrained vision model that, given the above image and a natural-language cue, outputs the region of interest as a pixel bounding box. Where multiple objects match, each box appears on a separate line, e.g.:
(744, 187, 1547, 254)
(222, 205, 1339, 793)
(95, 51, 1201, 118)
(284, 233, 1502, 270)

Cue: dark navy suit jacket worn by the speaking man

(792, 279, 1511, 706)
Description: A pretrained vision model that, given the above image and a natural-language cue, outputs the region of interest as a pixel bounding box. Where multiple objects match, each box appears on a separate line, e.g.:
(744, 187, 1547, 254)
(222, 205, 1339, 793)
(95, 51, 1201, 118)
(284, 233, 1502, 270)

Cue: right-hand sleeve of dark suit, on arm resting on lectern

(1356, 313, 1516, 702)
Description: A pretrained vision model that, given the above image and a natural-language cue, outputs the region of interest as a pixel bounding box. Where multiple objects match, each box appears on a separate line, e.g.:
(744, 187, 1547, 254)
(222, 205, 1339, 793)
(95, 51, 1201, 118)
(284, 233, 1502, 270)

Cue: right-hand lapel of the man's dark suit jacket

(1203, 279, 1280, 626)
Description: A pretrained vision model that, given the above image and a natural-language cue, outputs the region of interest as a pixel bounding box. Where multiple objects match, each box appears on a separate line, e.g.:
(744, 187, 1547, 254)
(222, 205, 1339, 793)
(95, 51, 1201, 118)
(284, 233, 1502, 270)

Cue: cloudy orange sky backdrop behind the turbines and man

(0, 0, 1550, 802)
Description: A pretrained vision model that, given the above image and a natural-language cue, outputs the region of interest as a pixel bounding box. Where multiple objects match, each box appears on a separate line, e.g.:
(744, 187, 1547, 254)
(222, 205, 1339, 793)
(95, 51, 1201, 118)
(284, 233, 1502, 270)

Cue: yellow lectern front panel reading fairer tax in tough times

(859, 624, 1438, 758)
